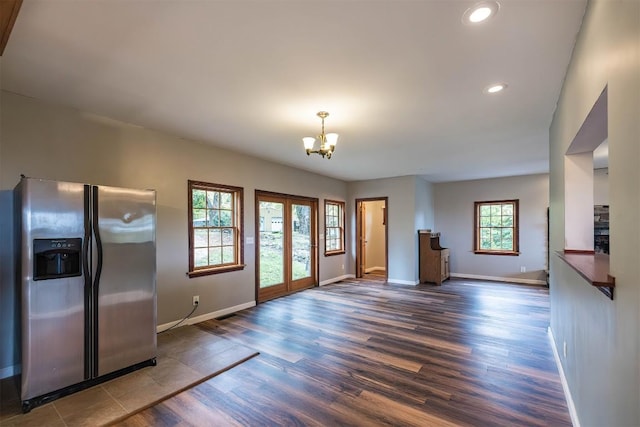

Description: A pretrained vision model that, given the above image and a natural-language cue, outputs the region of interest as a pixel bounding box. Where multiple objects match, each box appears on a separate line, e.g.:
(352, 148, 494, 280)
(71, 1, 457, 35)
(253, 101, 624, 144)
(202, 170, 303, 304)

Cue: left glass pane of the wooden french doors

(259, 201, 284, 288)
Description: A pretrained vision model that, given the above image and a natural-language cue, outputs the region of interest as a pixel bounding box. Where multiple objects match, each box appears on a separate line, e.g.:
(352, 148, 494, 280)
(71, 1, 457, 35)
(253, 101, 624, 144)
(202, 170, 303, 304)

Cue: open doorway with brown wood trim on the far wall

(356, 197, 389, 282)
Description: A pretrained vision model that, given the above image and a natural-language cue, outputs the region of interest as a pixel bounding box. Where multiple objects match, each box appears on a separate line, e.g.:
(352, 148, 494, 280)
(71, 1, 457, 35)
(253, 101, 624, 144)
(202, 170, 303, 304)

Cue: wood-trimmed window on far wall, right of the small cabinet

(473, 200, 520, 255)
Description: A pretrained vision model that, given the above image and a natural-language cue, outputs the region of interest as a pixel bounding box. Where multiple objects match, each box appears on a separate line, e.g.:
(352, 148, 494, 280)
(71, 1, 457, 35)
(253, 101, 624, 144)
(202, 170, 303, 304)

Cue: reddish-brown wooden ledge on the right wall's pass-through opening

(556, 250, 616, 299)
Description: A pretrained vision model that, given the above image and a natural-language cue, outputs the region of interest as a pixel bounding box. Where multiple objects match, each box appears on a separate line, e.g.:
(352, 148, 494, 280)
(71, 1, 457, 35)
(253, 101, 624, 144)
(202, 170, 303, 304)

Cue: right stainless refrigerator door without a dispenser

(93, 187, 156, 376)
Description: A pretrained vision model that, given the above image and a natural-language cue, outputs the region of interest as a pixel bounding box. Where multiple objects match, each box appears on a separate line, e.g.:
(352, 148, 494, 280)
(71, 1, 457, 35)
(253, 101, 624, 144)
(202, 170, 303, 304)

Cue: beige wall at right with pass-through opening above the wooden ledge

(549, 0, 640, 426)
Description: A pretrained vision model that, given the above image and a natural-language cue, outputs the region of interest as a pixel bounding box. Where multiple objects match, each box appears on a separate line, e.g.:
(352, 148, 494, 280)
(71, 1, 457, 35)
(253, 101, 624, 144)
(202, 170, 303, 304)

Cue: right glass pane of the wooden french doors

(291, 204, 311, 280)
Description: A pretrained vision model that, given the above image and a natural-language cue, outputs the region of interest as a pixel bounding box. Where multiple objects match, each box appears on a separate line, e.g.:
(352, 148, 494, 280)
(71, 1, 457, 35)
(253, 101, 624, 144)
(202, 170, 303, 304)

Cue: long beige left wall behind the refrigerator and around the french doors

(0, 92, 349, 376)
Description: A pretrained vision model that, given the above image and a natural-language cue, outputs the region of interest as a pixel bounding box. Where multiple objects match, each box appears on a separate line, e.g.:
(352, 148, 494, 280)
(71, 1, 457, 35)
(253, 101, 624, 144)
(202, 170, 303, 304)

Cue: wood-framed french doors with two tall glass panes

(256, 191, 318, 302)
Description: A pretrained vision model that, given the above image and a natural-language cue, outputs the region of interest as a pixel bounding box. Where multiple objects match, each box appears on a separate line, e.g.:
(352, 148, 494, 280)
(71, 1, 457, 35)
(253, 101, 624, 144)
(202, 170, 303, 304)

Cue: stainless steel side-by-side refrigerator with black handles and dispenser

(15, 177, 156, 412)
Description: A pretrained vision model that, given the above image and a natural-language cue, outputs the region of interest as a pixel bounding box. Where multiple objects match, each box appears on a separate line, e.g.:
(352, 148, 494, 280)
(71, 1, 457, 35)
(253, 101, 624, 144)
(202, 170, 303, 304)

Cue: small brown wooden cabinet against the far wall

(418, 230, 449, 285)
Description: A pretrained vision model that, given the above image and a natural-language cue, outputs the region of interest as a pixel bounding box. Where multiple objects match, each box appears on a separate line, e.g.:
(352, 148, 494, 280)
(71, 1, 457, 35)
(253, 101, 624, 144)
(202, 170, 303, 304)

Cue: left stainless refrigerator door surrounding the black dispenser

(18, 178, 85, 400)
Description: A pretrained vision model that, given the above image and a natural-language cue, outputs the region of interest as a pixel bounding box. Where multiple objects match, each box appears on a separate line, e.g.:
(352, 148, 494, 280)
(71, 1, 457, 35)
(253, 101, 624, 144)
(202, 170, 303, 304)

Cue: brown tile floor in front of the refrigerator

(0, 326, 257, 427)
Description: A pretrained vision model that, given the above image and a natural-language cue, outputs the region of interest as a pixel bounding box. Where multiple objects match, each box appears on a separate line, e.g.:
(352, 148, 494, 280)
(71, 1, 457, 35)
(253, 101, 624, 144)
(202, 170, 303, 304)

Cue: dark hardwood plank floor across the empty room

(121, 279, 571, 427)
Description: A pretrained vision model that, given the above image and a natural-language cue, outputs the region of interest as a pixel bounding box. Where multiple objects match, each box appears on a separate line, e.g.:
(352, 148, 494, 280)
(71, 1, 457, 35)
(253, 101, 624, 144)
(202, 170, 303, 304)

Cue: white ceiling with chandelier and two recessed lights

(1, 0, 586, 182)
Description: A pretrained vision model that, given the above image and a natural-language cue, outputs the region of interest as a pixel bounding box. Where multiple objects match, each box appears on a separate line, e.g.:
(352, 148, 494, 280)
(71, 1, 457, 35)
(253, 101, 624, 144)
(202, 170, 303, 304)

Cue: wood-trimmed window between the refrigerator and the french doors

(188, 180, 244, 277)
